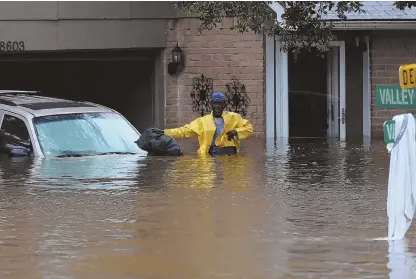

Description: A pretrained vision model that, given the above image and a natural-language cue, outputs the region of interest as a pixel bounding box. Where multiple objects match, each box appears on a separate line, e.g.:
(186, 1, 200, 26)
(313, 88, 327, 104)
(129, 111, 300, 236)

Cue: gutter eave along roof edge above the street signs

(332, 20, 416, 30)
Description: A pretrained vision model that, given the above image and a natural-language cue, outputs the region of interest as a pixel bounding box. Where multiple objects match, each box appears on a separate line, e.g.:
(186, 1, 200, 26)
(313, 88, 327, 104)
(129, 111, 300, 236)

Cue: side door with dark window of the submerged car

(0, 112, 33, 156)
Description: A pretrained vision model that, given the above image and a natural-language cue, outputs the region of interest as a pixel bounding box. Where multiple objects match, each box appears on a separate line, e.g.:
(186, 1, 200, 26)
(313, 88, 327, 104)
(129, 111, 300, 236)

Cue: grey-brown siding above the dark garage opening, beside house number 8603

(0, 1, 178, 51)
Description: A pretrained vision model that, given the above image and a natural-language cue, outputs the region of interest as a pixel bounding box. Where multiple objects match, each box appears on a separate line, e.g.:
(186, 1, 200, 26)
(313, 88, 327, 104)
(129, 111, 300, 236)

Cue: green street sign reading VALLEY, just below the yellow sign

(376, 85, 416, 109)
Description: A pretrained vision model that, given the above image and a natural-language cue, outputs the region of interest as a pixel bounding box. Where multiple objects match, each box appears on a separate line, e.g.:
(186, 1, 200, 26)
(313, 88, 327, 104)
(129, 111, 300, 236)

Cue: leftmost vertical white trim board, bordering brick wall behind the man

(265, 36, 276, 138)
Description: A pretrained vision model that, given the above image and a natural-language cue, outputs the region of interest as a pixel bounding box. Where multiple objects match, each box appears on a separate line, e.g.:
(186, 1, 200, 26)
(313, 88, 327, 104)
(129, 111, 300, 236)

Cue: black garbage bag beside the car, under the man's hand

(136, 128, 183, 156)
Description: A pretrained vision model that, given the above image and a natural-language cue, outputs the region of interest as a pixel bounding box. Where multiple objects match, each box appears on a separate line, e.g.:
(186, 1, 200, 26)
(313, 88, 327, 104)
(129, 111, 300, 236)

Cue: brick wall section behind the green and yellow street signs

(370, 31, 416, 138)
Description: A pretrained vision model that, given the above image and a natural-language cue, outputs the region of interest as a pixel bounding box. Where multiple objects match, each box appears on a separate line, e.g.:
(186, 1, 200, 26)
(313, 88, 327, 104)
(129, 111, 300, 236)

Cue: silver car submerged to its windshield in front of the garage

(0, 90, 146, 157)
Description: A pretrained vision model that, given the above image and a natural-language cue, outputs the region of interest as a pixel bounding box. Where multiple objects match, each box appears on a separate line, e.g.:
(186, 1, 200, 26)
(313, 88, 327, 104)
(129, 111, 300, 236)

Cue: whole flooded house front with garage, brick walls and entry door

(0, 1, 416, 140)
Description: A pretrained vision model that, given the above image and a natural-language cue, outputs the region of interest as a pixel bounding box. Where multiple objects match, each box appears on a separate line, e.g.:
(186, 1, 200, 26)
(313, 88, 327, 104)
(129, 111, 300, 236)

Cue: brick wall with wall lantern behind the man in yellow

(164, 18, 265, 135)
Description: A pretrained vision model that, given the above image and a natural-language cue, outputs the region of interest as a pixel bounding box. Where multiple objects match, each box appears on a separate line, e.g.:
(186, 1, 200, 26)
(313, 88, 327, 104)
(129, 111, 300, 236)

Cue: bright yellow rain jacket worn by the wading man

(164, 111, 253, 155)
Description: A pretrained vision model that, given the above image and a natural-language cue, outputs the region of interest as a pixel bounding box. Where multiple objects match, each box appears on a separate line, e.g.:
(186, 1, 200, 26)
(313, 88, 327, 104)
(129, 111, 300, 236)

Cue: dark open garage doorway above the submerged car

(0, 50, 155, 131)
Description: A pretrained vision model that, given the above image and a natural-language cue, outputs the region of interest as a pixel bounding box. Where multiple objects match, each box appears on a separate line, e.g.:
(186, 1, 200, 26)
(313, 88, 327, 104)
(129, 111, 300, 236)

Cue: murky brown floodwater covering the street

(0, 139, 410, 279)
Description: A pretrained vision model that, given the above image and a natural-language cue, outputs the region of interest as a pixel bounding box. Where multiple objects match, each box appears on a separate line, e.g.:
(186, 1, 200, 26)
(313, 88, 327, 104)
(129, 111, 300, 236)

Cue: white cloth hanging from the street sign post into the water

(387, 113, 416, 240)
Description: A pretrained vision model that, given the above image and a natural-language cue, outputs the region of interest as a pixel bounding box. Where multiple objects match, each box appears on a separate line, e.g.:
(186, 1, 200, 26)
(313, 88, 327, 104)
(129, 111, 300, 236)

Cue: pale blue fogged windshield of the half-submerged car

(33, 112, 143, 159)
